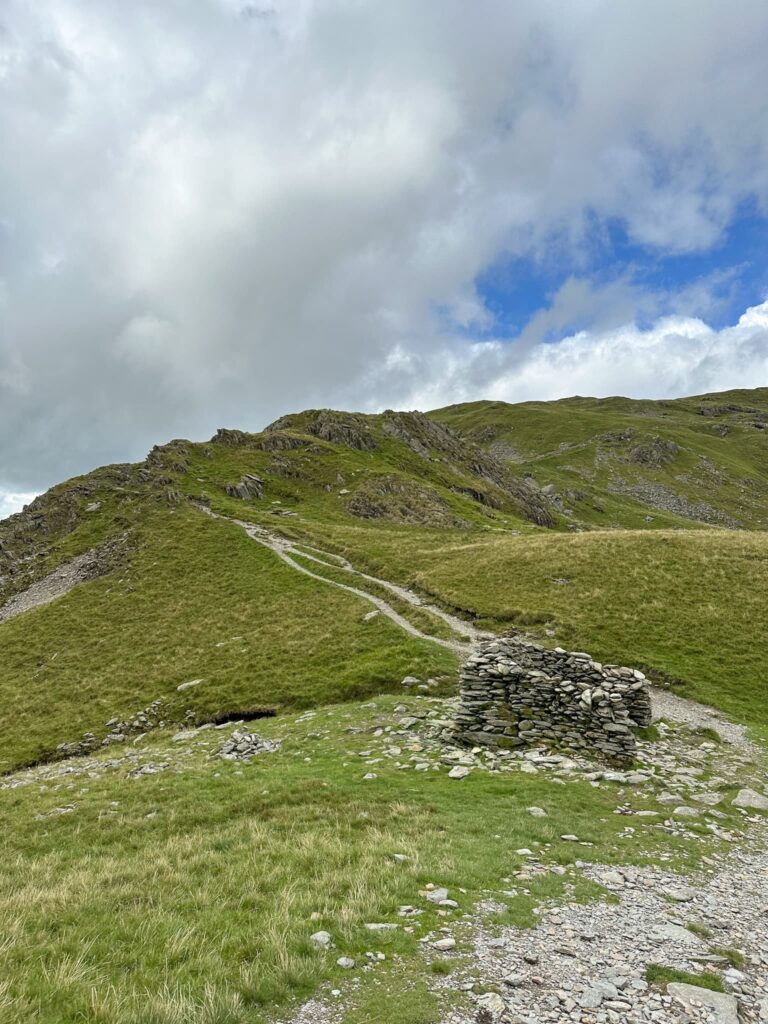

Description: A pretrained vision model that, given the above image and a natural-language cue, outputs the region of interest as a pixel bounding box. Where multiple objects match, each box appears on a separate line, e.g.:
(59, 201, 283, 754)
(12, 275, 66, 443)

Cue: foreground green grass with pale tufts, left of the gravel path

(0, 697, 745, 1024)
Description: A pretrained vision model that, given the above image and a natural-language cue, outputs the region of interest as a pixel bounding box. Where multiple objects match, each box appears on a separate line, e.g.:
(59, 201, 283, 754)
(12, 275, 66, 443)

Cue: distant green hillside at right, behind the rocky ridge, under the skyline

(430, 388, 768, 529)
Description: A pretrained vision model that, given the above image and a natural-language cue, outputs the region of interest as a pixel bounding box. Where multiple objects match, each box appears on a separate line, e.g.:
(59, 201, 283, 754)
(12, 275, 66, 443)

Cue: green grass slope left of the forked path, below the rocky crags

(0, 507, 457, 769)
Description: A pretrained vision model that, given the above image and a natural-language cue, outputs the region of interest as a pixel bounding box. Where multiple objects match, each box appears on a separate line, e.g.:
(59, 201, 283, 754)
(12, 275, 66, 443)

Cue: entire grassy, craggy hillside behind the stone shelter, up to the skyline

(0, 389, 768, 768)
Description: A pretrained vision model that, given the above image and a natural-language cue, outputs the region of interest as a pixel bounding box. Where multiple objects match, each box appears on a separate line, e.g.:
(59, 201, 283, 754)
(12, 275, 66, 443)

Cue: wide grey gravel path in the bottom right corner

(443, 819, 768, 1024)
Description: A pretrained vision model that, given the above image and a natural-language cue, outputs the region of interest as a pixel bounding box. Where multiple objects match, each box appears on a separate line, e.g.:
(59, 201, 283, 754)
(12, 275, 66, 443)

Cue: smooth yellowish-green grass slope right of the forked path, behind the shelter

(286, 522, 768, 730)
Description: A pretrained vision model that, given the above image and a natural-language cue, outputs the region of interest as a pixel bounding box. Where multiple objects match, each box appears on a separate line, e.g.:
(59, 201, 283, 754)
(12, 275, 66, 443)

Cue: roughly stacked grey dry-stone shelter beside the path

(456, 638, 651, 762)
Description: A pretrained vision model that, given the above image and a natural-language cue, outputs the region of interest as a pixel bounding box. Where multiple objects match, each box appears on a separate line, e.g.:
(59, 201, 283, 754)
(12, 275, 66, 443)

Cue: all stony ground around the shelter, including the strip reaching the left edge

(0, 655, 768, 1024)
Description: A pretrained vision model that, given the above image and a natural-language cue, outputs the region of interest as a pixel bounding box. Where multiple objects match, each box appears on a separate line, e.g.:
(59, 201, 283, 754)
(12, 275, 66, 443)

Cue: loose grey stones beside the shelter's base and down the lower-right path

(268, 694, 768, 1024)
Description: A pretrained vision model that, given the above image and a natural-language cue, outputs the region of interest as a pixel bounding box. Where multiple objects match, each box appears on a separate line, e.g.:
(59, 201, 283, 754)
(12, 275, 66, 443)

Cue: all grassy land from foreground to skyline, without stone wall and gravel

(0, 390, 768, 1024)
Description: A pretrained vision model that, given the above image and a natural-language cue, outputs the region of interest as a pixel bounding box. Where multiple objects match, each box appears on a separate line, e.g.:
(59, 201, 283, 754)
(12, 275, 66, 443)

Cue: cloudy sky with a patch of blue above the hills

(0, 0, 768, 516)
